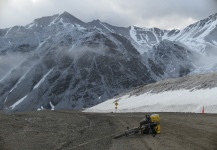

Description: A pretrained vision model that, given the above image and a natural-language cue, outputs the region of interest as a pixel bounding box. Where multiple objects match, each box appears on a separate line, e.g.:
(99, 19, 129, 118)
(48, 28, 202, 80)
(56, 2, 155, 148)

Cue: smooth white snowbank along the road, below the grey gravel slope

(84, 88, 217, 113)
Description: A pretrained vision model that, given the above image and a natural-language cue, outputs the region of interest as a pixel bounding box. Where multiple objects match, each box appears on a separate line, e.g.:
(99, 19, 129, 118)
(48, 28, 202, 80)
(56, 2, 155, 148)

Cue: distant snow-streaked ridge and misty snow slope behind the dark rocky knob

(130, 13, 217, 74)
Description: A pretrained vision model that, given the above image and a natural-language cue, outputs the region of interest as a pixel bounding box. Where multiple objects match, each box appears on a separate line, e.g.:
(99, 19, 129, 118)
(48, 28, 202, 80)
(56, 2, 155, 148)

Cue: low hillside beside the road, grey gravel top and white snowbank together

(84, 73, 217, 113)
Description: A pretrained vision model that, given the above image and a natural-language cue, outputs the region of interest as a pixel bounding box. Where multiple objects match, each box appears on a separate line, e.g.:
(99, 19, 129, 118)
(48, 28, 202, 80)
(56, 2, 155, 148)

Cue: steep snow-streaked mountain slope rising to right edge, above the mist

(167, 14, 217, 55)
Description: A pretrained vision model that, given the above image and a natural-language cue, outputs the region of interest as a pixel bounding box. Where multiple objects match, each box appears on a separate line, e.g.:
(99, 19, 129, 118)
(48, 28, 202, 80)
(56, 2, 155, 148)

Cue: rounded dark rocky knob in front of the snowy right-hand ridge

(148, 40, 194, 77)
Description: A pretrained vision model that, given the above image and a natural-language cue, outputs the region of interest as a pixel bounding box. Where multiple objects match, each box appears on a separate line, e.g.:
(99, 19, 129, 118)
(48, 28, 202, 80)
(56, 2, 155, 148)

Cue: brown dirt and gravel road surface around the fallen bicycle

(0, 111, 217, 150)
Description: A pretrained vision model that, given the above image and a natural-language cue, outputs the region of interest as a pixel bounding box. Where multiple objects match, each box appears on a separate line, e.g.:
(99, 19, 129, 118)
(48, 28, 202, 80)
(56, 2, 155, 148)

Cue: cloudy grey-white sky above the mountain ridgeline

(0, 0, 217, 29)
